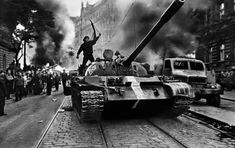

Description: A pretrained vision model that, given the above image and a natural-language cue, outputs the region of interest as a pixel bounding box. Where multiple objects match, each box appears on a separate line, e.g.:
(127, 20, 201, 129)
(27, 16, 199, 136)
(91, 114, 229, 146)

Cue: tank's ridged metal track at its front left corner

(79, 91, 105, 121)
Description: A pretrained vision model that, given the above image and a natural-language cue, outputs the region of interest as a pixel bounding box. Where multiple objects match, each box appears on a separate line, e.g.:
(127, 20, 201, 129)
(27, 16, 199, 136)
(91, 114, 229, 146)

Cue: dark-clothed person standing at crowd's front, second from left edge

(14, 72, 24, 101)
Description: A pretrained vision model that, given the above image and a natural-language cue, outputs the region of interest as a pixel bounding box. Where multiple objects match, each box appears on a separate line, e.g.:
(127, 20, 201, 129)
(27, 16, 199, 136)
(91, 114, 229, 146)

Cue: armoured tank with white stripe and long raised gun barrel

(66, 0, 194, 121)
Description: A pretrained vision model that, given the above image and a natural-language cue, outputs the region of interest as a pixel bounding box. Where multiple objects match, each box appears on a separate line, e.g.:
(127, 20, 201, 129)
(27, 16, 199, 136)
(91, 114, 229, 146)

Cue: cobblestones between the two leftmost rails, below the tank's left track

(40, 97, 104, 148)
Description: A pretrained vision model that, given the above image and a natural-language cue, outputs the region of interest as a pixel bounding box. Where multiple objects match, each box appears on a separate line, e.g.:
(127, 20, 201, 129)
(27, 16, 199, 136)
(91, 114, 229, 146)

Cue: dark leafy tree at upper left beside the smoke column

(0, 0, 55, 68)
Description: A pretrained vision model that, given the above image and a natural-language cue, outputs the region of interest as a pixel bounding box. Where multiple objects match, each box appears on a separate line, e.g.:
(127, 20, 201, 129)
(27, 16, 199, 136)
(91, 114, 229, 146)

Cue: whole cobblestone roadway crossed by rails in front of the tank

(37, 92, 235, 148)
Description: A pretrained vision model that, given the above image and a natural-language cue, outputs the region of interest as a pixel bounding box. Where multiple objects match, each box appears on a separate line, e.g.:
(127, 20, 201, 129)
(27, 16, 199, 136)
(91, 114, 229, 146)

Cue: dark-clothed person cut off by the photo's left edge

(0, 71, 7, 116)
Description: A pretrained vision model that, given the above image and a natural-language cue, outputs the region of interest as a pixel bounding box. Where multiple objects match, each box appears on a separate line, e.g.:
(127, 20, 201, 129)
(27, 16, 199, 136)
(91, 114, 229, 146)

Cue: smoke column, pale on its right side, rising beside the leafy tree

(32, 0, 75, 67)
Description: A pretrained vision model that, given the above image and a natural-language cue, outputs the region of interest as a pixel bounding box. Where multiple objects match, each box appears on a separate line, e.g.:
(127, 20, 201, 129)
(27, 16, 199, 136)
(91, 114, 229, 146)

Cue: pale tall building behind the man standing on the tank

(72, 0, 120, 56)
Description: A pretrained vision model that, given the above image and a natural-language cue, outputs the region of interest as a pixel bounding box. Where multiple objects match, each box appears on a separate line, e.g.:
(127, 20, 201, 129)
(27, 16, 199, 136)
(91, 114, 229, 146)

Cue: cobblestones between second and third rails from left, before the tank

(103, 120, 182, 148)
